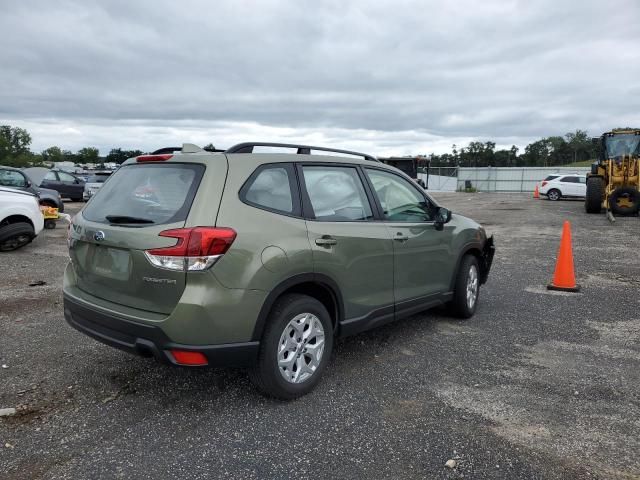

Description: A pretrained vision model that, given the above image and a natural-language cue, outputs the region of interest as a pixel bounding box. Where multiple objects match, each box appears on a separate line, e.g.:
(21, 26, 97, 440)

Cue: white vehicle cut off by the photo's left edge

(0, 187, 44, 252)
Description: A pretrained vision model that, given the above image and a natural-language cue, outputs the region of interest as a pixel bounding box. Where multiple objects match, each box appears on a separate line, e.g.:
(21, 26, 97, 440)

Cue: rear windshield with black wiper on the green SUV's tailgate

(82, 163, 204, 226)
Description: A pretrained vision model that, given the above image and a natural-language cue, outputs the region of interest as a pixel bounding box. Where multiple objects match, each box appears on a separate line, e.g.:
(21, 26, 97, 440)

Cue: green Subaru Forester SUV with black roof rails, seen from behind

(64, 143, 494, 399)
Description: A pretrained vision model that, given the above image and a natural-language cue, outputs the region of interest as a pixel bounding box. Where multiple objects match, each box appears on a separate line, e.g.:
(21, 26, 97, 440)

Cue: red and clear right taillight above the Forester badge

(144, 227, 236, 272)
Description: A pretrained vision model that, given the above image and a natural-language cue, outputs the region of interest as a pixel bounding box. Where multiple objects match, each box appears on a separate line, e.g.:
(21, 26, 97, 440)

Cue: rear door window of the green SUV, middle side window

(302, 165, 373, 222)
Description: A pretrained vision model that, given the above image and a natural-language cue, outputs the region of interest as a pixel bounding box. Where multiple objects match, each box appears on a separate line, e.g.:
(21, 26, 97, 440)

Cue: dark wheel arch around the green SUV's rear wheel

(251, 273, 344, 341)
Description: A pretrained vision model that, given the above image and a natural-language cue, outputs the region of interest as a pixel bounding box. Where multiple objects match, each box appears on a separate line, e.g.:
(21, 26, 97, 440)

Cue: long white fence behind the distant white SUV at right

(456, 167, 590, 192)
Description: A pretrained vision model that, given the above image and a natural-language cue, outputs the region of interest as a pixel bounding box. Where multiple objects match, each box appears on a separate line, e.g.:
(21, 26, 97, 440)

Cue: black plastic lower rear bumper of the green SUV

(64, 295, 260, 367)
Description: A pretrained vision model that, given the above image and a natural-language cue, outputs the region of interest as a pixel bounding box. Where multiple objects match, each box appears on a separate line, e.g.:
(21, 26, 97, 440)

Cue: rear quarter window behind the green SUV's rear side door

(240, 164, 298, 214)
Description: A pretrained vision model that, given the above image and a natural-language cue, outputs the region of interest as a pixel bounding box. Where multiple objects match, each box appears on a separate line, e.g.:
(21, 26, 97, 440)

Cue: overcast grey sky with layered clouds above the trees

(0, 0, 640, 155)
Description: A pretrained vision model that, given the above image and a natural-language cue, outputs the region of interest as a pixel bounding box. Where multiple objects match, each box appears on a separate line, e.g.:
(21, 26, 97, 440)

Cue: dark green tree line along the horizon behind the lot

(0, 125, 599, 167)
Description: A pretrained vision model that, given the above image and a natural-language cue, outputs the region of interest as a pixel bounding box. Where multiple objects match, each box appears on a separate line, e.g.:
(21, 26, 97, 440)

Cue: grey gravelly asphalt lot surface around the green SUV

(0, 194, 640, 480)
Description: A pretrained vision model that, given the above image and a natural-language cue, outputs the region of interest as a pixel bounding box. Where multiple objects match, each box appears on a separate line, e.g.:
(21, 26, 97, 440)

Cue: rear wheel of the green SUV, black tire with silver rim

(249, 294, 333, 400)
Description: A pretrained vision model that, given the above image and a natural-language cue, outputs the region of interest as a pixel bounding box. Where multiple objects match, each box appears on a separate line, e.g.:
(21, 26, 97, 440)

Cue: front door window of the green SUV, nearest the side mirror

(366, 168, 434, 222)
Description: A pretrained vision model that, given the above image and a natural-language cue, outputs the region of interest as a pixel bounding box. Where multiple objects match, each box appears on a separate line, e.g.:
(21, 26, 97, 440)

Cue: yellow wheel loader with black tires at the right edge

(584, 129, 640, 220)
